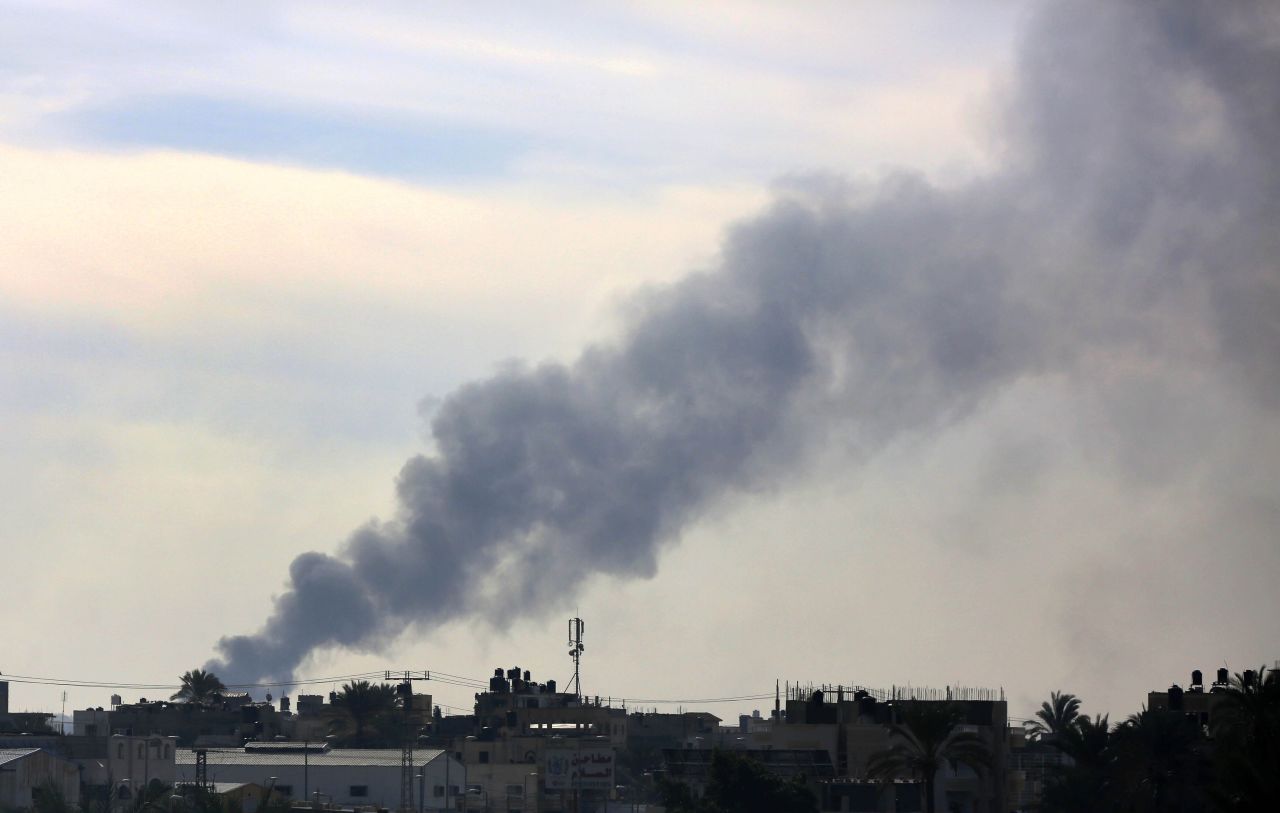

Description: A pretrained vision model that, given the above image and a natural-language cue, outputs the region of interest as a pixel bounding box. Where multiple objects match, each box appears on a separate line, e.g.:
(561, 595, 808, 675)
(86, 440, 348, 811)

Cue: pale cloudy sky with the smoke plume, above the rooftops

(0, 0, 1280, 717)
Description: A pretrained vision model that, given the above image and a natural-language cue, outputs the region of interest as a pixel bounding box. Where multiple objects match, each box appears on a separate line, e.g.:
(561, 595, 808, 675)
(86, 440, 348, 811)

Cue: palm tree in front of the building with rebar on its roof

(867, 700, 991, 813)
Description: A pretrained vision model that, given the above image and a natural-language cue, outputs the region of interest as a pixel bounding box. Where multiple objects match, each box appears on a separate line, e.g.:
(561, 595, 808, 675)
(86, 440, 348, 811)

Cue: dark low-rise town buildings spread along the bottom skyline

(0, 667, 1259, 813)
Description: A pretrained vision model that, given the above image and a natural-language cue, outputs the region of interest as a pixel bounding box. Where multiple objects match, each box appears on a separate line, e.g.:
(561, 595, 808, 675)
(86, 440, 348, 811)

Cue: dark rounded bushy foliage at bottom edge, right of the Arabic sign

(660, 750, 818, 813)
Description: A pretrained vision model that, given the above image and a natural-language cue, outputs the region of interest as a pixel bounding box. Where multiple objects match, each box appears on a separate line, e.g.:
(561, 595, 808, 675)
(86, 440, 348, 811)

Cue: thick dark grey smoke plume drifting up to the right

(210, 1, 1280, 681)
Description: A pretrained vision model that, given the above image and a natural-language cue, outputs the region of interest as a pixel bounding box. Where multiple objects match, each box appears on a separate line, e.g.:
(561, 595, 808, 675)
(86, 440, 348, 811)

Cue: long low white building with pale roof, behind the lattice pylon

(178, 743, 466, 810)
